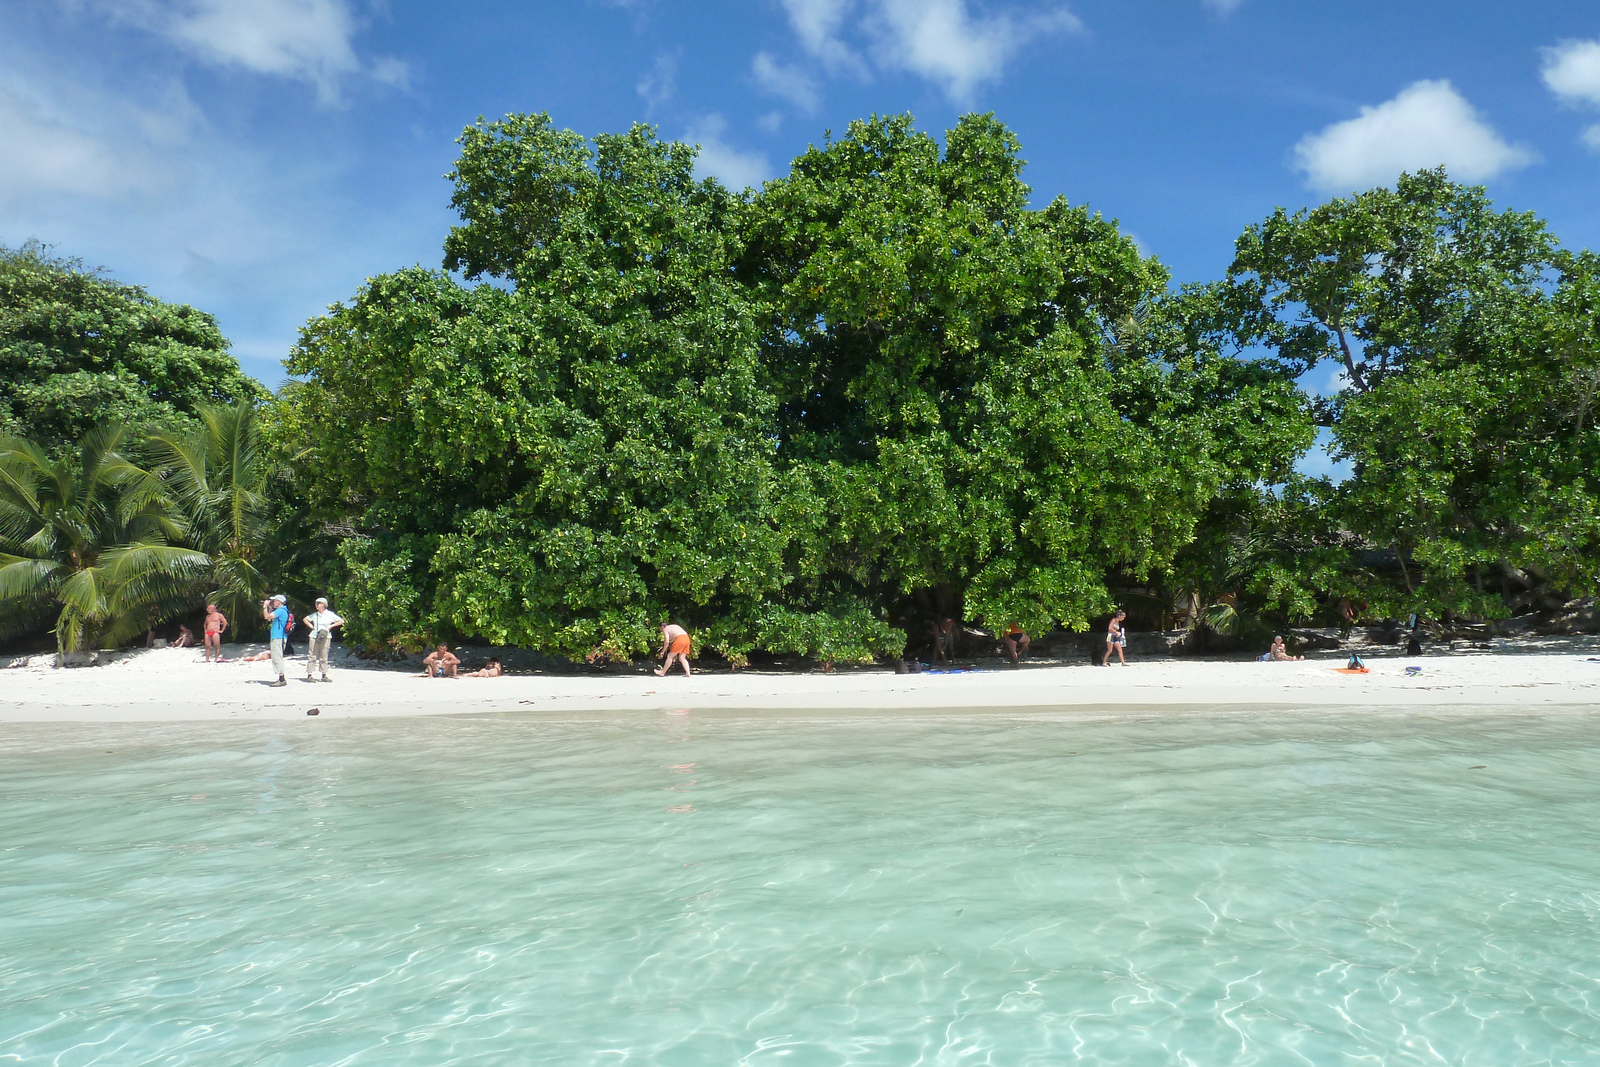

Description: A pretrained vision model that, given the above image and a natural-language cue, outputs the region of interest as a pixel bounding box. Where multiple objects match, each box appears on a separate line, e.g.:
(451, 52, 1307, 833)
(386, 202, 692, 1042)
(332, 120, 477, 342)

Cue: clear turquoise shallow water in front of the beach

(0, 712, 1600, 1067)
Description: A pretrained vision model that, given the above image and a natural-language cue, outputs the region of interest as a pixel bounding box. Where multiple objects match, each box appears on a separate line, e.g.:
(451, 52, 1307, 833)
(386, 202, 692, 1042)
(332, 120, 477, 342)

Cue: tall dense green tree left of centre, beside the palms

(282, 115, 894, 656)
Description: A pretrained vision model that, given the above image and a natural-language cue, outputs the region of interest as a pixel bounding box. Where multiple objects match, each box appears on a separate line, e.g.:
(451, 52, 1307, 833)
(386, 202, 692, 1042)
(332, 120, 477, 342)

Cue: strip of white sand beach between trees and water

(0, 637, 1600, 721)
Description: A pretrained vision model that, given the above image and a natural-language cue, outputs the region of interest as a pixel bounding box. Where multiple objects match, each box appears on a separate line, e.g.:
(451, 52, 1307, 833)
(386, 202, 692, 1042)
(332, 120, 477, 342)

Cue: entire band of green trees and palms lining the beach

(15, 115, 1600, 664)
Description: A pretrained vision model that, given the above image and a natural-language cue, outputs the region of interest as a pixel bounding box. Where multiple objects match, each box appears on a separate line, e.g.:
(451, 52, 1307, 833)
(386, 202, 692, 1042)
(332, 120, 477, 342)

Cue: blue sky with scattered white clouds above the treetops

(0, 0, 1600, 396)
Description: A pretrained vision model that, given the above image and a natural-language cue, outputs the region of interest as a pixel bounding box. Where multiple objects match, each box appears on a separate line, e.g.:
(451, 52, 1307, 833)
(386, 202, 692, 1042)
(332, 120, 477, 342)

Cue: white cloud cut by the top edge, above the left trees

(102, 0, 408, 101)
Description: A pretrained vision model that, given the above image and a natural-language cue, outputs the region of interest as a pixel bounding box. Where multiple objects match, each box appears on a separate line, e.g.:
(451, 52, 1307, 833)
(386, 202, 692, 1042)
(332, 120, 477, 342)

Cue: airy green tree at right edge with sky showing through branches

(1222, 171, 1600, 616)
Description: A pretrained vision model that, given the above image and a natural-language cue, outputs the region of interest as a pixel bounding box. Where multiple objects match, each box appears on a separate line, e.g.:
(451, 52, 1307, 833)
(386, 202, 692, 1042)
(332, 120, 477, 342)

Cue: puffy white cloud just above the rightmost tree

(1294, 82, 1534, 192)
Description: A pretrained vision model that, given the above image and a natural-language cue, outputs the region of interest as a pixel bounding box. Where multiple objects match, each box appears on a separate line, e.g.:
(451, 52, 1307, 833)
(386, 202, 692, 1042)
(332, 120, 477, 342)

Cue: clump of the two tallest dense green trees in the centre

(283, 115, 1310, 659)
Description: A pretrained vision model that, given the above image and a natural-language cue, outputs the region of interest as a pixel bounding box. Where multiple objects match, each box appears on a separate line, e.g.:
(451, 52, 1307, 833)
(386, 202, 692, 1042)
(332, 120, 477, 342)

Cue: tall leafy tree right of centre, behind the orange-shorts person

(739, 115, 1310, 629)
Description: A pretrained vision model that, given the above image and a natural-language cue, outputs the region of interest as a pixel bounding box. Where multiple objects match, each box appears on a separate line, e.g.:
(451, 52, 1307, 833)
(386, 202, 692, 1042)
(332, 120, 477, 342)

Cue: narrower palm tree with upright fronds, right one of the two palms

(146, 402, 272, 619)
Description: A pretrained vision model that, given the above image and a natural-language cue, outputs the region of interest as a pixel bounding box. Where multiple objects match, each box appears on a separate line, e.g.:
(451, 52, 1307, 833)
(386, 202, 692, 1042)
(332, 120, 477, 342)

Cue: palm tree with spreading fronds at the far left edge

(0, 426, 208, 665)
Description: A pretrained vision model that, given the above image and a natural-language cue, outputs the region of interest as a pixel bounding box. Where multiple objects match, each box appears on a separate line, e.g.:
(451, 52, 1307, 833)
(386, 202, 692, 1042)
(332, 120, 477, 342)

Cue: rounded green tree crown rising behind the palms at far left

(0, 245, 266, 453)
